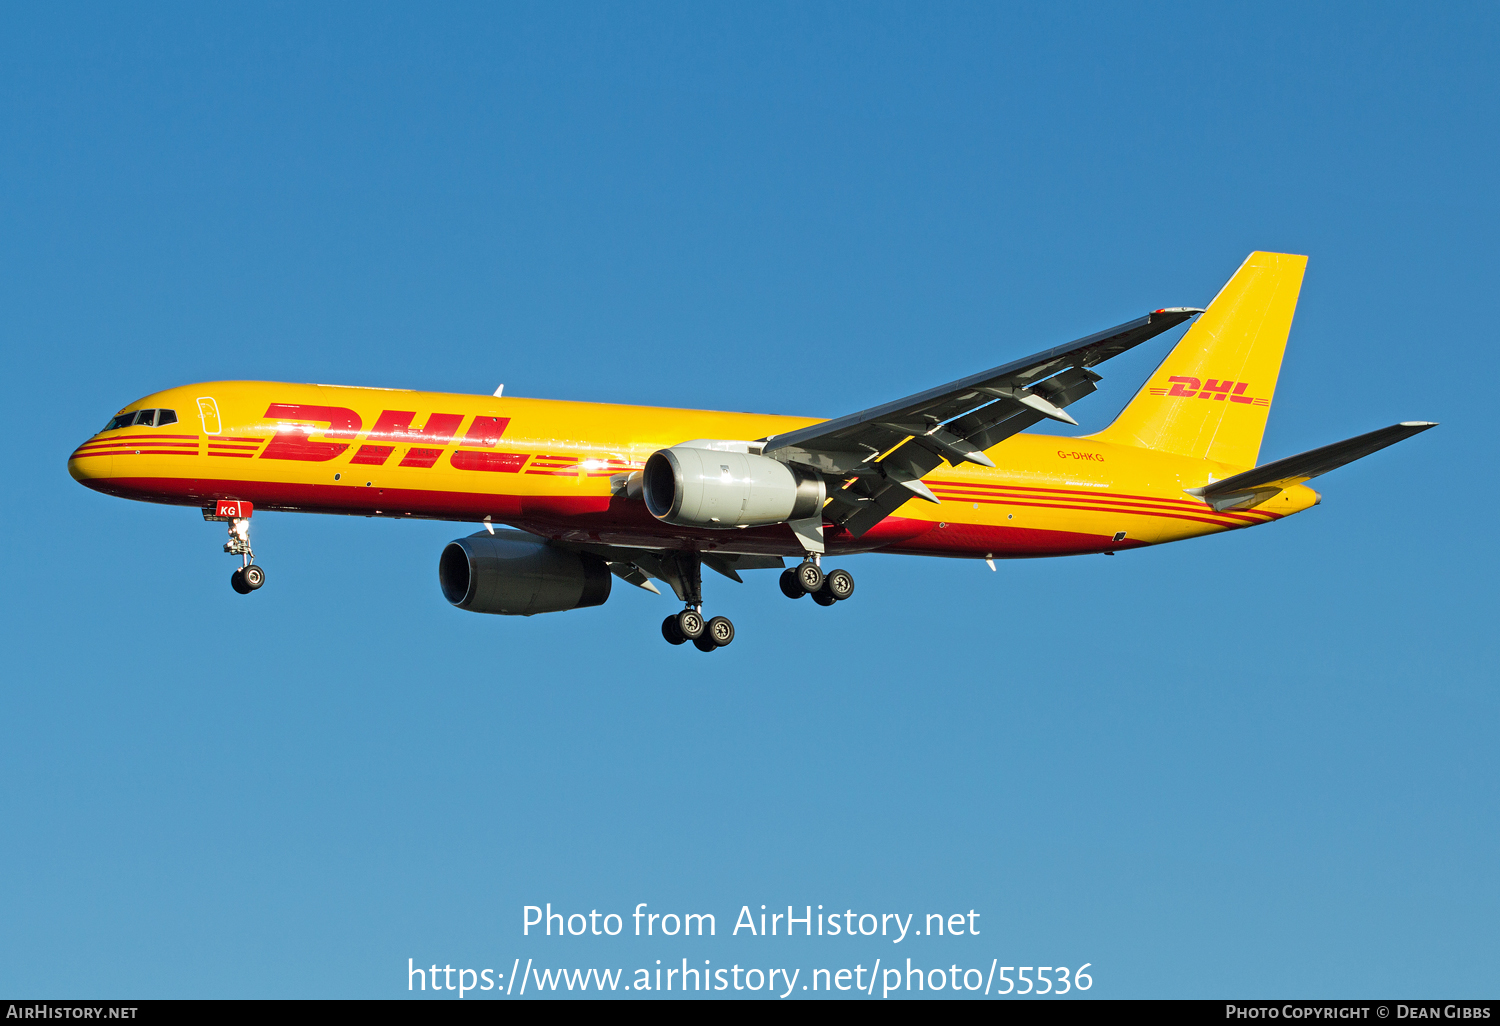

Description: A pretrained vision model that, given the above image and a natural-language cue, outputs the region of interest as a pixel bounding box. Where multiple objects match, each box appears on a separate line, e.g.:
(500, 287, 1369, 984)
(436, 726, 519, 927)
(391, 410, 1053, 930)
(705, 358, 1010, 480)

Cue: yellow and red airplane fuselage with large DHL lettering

(68, 381, 1319, 558)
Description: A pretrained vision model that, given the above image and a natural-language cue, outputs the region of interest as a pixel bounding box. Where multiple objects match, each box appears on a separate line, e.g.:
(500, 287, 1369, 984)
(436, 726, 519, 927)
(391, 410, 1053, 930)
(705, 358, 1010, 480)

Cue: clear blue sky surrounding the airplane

(0, 5, 1500, 998)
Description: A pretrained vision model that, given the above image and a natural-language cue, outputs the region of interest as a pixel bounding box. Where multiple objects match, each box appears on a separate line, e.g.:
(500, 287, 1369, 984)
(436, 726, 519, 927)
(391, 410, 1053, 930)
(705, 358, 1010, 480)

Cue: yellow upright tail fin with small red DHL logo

(1094, 252, 1308, 467)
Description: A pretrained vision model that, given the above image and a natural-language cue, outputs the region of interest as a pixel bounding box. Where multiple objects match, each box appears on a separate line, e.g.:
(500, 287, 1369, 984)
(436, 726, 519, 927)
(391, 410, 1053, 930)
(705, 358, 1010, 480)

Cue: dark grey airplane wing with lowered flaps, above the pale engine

(762, 306, 1203, 536)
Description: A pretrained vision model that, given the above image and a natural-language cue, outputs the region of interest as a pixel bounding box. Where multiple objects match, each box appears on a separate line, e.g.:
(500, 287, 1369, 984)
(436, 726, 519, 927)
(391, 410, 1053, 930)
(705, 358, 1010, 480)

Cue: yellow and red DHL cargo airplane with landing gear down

(68, 252, 1434, 651)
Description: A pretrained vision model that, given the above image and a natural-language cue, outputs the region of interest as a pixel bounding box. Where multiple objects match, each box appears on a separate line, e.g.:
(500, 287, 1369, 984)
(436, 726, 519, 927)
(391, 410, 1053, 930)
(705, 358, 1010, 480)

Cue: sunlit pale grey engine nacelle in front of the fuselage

(641, 443, 828, 528)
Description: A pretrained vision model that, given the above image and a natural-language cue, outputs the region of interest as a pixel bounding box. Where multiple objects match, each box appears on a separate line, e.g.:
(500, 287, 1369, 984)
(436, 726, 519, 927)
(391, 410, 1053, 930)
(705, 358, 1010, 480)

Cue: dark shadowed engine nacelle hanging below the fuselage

(438, 531, 614, 617)
